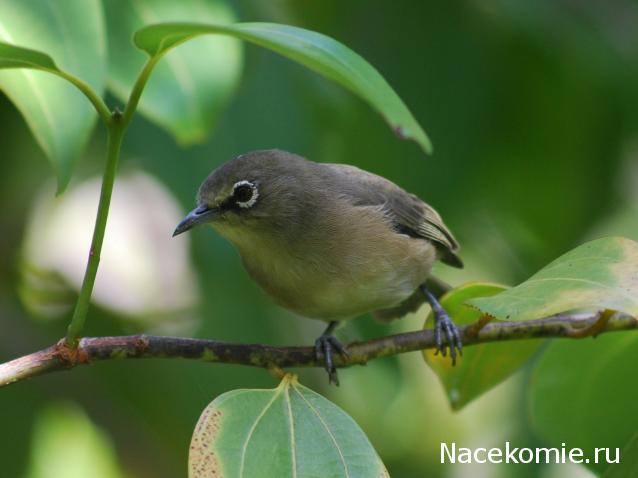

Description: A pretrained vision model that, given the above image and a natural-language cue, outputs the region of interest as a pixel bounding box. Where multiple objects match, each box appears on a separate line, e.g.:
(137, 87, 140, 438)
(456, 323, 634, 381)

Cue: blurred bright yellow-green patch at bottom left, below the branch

(26, 404, 125, 478)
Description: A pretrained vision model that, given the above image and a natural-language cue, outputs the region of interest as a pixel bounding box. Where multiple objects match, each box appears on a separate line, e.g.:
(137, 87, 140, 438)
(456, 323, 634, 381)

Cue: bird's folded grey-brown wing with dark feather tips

(326, 164, 463, 268)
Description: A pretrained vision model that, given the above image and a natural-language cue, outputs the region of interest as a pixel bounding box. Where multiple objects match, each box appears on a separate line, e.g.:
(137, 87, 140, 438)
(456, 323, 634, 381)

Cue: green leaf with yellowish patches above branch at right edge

(469, 237, 638, 320)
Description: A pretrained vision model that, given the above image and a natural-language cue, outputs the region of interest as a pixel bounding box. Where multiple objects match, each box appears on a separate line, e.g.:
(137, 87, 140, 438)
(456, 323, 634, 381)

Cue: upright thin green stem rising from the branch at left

(66, 117, 125, 347)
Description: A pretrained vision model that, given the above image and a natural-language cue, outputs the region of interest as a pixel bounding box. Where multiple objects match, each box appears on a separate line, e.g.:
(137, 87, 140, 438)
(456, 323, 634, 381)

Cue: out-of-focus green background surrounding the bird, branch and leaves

(0, 0, 638, 478)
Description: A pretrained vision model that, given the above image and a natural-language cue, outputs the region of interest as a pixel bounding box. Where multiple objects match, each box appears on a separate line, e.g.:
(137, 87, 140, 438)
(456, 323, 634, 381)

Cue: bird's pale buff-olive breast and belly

(212, 202, 436, 320)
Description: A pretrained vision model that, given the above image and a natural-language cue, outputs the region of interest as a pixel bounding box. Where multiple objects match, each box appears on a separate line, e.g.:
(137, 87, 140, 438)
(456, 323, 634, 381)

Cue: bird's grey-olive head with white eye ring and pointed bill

(173, 150, 313, 239)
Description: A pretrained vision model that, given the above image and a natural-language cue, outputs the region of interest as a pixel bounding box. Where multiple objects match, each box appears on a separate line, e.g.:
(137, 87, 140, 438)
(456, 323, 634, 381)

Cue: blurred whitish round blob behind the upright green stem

(21, 172, 199, 334)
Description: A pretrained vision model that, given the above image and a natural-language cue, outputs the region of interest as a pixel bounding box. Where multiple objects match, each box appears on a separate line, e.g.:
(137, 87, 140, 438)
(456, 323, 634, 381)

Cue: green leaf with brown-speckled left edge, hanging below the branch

(188, 375, 389, 478)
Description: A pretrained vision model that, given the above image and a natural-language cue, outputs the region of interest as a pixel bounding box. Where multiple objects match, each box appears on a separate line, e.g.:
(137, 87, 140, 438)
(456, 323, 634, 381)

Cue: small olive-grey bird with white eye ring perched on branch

(173, 150, 462, 383)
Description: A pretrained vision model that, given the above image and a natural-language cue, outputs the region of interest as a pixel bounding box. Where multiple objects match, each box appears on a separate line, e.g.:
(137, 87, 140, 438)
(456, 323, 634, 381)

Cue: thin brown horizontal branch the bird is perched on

(0, 311, 638, 386)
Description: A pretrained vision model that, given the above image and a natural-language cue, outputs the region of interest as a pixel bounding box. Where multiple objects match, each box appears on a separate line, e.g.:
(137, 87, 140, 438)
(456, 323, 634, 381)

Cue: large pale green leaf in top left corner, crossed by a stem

(0, 0, 106, 190)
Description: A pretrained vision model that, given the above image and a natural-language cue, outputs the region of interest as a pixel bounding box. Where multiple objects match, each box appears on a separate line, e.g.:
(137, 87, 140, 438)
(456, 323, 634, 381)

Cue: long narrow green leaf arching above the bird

(134, 23, 432, 153)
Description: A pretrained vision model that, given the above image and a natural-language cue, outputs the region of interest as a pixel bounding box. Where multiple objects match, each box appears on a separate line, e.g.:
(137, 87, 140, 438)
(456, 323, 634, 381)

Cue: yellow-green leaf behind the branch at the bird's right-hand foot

(423, 283, 543, 410)
